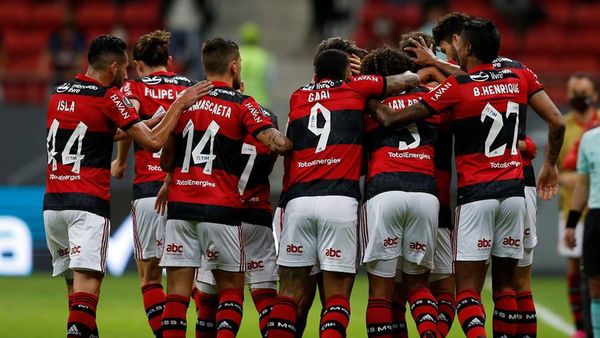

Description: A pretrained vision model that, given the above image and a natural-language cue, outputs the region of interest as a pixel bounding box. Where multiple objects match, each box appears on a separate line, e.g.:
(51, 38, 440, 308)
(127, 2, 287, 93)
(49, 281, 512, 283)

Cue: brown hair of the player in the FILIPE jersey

(133, 30, 171, 67)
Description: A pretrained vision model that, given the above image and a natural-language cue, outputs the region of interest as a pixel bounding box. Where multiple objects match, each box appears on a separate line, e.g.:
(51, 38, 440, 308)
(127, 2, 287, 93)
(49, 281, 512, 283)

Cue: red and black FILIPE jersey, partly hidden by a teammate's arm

(121, 71, 195, 200)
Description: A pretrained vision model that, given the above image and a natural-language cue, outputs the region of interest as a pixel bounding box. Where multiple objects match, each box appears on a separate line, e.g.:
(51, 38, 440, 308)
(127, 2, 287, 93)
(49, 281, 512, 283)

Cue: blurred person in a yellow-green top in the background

(240, 22, 275, 107)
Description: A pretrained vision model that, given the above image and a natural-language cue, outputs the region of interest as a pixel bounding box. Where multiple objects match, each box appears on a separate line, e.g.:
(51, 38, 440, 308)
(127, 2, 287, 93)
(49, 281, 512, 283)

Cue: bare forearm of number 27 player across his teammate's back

(367, 99, 431, 129)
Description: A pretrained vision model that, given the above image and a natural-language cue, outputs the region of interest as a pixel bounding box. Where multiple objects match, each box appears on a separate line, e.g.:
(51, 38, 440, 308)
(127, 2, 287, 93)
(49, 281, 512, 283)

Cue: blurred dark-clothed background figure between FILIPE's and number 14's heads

(161, 0, 215, 80)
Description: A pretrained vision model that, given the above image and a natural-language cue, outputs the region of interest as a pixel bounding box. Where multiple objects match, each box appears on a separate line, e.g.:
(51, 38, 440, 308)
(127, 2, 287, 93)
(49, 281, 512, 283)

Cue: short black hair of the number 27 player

(461, 18, 500, 63)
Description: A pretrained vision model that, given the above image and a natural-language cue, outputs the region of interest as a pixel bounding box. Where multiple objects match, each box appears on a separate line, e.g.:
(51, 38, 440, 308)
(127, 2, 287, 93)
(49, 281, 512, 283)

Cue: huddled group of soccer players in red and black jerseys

(44, 9, 564, 338)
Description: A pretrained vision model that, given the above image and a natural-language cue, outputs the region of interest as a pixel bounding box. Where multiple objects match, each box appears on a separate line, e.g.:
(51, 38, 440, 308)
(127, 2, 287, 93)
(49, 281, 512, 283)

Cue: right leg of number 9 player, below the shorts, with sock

(320, 271, 356, 338)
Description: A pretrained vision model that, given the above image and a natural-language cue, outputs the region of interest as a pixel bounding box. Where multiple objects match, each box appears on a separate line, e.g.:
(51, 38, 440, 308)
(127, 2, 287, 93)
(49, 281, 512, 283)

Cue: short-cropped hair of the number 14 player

(202, 38, 240, 75)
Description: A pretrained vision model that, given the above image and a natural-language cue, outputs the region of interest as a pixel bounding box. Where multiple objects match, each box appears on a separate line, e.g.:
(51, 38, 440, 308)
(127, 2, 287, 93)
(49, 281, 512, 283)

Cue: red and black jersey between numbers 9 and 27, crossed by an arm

(365, 87, 439, 199)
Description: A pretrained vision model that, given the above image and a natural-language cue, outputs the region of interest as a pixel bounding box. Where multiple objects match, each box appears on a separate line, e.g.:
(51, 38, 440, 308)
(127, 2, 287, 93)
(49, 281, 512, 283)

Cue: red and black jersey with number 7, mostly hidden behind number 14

(238, 108, 277, 227)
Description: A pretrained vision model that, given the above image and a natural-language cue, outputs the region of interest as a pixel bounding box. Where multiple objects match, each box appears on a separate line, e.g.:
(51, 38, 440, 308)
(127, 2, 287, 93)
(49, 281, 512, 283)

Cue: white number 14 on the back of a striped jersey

(181, 120, 220, 175)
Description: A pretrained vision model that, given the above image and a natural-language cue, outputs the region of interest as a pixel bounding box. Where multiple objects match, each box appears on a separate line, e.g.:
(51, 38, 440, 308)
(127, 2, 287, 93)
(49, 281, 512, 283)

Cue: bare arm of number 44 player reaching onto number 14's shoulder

(127, 81, 213, 152)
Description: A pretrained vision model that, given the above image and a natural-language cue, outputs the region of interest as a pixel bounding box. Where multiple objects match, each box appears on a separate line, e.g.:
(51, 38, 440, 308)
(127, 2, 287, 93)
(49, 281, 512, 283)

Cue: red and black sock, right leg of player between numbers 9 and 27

(408, 288, 438, 338)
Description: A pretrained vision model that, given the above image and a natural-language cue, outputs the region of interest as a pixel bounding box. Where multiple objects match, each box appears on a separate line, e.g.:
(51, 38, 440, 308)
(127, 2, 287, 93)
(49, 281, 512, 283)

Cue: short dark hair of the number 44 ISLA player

(88, 34, 127, 69)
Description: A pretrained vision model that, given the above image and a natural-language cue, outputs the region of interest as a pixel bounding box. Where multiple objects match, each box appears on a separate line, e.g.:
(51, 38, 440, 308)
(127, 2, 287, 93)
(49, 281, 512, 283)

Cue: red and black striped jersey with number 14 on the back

(167, 82, 273, 225)
